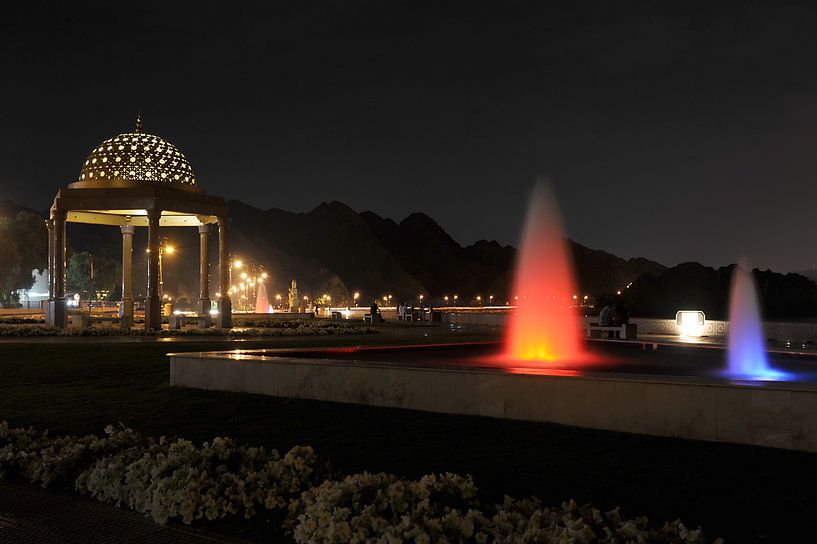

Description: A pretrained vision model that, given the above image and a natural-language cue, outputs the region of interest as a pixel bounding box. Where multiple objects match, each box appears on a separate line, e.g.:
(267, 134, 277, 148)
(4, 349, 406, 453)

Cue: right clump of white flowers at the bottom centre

(291, 473, 706, 544)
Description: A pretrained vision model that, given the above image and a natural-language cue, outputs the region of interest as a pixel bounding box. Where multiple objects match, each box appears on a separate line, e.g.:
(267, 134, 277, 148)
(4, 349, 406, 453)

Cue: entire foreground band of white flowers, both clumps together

(0, 421, 721, 544)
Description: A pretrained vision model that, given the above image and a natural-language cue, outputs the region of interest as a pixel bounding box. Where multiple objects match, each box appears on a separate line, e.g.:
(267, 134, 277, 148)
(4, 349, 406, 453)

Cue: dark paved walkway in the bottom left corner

(0, 481, 249, 544)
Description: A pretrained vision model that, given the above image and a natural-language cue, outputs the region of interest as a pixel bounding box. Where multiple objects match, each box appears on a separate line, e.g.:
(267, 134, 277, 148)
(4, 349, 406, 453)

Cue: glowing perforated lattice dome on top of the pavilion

(78, 120, 196, 188)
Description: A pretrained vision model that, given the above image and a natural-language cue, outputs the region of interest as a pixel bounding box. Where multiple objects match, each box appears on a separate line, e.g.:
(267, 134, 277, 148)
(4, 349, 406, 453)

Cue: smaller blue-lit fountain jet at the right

(725, 264, 786, 380)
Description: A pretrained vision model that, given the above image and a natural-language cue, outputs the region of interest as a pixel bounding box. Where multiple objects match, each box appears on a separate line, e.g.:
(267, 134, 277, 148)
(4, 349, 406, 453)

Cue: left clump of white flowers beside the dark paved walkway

(0, 422, 326, 524)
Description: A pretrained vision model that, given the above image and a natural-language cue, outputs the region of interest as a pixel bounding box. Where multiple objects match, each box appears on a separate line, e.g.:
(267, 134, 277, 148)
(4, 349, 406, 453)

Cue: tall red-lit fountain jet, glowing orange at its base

(506, 181, 588, 366)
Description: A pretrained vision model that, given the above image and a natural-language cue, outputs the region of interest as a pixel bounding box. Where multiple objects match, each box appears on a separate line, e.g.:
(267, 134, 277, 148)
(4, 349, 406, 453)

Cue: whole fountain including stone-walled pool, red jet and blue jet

(170, 184, 817, 452)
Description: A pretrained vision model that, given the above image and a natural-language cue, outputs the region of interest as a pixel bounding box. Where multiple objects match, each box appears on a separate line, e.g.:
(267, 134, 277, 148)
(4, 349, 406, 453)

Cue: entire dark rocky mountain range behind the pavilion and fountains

(6, 200, 817, 318)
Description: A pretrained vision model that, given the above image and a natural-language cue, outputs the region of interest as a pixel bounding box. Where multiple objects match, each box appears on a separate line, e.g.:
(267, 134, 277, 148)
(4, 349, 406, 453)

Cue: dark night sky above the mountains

(0, 0, 817, 271)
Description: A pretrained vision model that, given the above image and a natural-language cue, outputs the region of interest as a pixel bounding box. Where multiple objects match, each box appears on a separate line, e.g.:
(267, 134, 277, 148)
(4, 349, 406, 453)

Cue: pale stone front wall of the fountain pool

(170, 354, 817, 452)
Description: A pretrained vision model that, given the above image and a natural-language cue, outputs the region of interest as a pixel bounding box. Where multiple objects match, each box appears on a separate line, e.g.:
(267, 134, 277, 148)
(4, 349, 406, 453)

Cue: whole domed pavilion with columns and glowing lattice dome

(46, 116, 232, 330)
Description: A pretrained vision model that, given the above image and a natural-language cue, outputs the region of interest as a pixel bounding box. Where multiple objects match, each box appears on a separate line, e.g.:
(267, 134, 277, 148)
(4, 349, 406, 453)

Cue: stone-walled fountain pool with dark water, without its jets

(170, 342, 817, 452)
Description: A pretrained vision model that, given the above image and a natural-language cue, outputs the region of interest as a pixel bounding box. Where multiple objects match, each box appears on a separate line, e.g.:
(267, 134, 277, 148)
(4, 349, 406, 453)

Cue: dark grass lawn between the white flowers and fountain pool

(0, 329, 817, 542)
